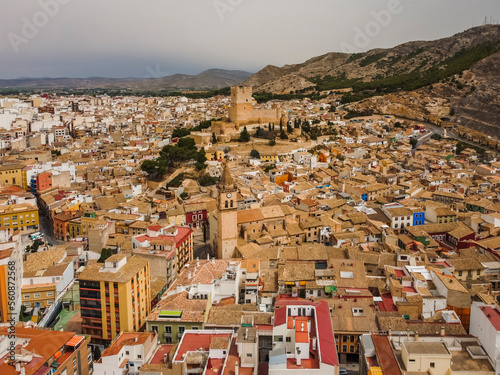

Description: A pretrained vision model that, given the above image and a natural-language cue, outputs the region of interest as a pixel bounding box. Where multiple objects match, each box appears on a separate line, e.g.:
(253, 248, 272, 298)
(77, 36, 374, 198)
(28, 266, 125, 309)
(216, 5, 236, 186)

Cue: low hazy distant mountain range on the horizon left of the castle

(0, 69, 252, 91)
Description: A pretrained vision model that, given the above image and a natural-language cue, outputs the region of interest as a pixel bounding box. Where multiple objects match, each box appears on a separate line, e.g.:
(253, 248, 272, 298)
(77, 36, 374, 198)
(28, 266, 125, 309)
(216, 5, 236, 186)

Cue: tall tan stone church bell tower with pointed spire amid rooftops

(217, 162, 238, 259)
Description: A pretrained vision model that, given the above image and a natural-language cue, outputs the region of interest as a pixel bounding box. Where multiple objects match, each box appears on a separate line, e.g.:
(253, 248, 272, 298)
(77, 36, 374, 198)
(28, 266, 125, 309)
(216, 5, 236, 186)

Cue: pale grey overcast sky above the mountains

(0, 0, 500, 79)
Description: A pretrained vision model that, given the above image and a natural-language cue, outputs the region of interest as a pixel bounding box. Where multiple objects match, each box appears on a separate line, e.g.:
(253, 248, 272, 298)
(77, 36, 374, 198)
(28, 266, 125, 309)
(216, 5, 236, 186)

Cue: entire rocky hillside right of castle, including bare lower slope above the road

(244, 25, 500, 138)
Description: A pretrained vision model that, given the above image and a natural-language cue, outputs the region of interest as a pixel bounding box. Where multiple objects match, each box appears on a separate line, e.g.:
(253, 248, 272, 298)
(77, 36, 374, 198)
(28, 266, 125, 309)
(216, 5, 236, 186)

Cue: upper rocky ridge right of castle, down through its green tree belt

(243, 25, 500, 94)
